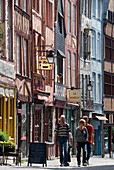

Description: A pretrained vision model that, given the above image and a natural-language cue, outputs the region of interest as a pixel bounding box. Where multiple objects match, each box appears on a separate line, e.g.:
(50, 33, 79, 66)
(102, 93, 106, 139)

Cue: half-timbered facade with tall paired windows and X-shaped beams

(13, 0, 32, 157)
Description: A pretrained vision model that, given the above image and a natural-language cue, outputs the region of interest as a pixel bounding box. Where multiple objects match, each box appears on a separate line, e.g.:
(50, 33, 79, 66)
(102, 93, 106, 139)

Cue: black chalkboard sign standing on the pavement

(28, 142, 47, 166)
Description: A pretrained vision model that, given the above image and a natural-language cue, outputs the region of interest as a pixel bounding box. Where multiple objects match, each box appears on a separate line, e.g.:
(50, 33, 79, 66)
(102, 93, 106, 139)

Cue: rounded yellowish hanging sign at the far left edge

(0, 23, 5, 47)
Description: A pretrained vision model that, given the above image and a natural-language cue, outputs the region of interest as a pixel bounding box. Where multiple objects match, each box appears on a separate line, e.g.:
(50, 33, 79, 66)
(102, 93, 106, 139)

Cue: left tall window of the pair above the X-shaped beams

(17, 36, 21, 74)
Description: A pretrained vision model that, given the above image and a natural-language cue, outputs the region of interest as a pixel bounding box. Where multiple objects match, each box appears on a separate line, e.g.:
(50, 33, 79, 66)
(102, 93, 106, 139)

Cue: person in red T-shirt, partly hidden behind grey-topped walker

(83, 116, 94, 165)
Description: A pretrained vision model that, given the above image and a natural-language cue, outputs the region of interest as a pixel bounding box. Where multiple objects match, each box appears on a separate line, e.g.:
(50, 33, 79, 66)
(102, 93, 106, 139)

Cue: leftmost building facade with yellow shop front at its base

(0, 0, 16, 143)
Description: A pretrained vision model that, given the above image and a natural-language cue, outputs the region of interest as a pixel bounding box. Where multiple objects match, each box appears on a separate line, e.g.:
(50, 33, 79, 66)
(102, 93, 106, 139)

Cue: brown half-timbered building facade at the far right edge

(104, 0, 114, 157)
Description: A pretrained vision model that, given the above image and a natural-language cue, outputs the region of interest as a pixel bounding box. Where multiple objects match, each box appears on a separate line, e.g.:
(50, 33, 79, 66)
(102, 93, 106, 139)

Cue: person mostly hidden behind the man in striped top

(68, 132, 73, 162)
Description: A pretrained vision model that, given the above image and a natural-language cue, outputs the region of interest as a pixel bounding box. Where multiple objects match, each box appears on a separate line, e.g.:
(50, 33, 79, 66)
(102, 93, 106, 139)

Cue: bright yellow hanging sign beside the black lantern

(39, 56, 52, 70)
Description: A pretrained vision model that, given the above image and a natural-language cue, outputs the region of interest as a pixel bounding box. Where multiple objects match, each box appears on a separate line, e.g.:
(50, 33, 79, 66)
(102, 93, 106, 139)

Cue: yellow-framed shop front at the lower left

(0, 84, 16, 143)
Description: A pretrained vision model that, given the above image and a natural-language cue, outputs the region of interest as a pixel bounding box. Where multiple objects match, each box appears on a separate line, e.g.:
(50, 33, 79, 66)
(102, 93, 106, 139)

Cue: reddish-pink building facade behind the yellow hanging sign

(31, 0, 55, 159)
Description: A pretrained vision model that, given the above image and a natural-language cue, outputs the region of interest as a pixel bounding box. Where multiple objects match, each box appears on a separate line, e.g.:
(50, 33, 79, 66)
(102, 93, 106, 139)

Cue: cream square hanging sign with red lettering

(67, 89, 81, 103)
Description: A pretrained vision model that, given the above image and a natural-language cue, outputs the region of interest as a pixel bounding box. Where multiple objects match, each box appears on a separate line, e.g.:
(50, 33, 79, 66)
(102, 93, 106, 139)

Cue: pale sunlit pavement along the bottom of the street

(0, 157, 114, 170)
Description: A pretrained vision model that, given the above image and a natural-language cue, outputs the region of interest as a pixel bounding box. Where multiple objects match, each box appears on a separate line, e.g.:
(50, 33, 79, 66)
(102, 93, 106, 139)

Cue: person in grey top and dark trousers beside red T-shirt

(75, 119, 88, 167)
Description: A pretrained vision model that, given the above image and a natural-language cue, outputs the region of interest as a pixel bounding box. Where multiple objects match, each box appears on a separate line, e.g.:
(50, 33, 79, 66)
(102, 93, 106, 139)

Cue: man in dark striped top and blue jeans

(55, 115, 71, 166)
